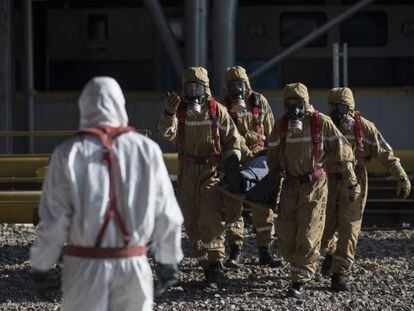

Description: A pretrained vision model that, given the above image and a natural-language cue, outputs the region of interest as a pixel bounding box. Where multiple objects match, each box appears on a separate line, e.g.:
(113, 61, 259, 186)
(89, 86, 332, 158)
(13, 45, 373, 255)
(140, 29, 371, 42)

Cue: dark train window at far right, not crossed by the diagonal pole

(341, 11, 388, 47)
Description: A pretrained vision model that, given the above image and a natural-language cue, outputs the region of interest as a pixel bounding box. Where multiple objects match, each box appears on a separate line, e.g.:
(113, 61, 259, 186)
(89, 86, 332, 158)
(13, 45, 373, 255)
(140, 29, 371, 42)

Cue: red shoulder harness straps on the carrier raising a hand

(178, 98, 221, 155)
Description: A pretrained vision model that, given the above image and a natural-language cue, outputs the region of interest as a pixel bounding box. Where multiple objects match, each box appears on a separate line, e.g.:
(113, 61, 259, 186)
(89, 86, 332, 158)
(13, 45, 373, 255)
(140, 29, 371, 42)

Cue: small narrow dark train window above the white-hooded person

(88, 15, 108, 51)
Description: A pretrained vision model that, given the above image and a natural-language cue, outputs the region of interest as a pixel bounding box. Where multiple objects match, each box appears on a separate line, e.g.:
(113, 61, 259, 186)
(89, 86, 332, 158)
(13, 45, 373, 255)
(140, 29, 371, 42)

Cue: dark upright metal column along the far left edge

(0, 0, 13, 154)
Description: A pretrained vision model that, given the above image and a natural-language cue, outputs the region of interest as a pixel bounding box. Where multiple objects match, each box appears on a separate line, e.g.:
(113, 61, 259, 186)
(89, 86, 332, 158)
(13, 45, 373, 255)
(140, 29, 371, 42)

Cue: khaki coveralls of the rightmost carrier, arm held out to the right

(321, 88, 407, 275)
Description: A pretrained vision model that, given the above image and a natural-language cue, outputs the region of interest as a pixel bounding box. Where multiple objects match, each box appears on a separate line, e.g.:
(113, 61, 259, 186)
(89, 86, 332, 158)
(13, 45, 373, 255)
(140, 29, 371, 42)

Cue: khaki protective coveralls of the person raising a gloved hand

(157, 67, 241, 262)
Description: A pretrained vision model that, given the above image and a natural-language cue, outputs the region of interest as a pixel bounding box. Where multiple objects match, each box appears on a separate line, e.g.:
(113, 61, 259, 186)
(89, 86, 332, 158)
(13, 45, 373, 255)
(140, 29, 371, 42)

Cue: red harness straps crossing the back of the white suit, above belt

(79, 127, 135, 248)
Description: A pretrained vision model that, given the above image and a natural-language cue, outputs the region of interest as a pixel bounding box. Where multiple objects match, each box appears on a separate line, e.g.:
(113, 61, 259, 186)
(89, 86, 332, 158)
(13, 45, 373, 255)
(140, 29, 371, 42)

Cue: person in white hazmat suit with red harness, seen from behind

(30, 77, 183, 311)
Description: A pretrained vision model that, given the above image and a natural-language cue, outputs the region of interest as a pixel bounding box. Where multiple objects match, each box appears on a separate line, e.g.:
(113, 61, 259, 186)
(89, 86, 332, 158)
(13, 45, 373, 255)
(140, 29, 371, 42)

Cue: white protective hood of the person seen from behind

(79, 77, 128, 129)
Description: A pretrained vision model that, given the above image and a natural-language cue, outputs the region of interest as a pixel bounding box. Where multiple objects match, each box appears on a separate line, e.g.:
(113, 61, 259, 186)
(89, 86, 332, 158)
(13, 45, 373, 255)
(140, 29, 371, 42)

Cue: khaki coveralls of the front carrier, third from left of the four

(267, 83, 356, 283)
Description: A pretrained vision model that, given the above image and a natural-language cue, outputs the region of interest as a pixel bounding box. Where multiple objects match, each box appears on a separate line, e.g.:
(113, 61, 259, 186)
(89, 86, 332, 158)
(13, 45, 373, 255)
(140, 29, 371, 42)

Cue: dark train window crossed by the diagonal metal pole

(280, 12, 327, 47)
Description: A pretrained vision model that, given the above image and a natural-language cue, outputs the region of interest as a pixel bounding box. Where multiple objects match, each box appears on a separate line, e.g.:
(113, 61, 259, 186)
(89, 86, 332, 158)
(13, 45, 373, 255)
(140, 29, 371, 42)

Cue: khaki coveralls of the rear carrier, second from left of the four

(224, 66, 275, 247)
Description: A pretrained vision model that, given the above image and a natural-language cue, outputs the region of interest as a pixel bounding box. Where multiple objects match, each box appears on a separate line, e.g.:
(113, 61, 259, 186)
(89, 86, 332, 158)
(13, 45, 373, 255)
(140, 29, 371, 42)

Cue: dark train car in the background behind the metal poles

(10, 0, 414, 91)
